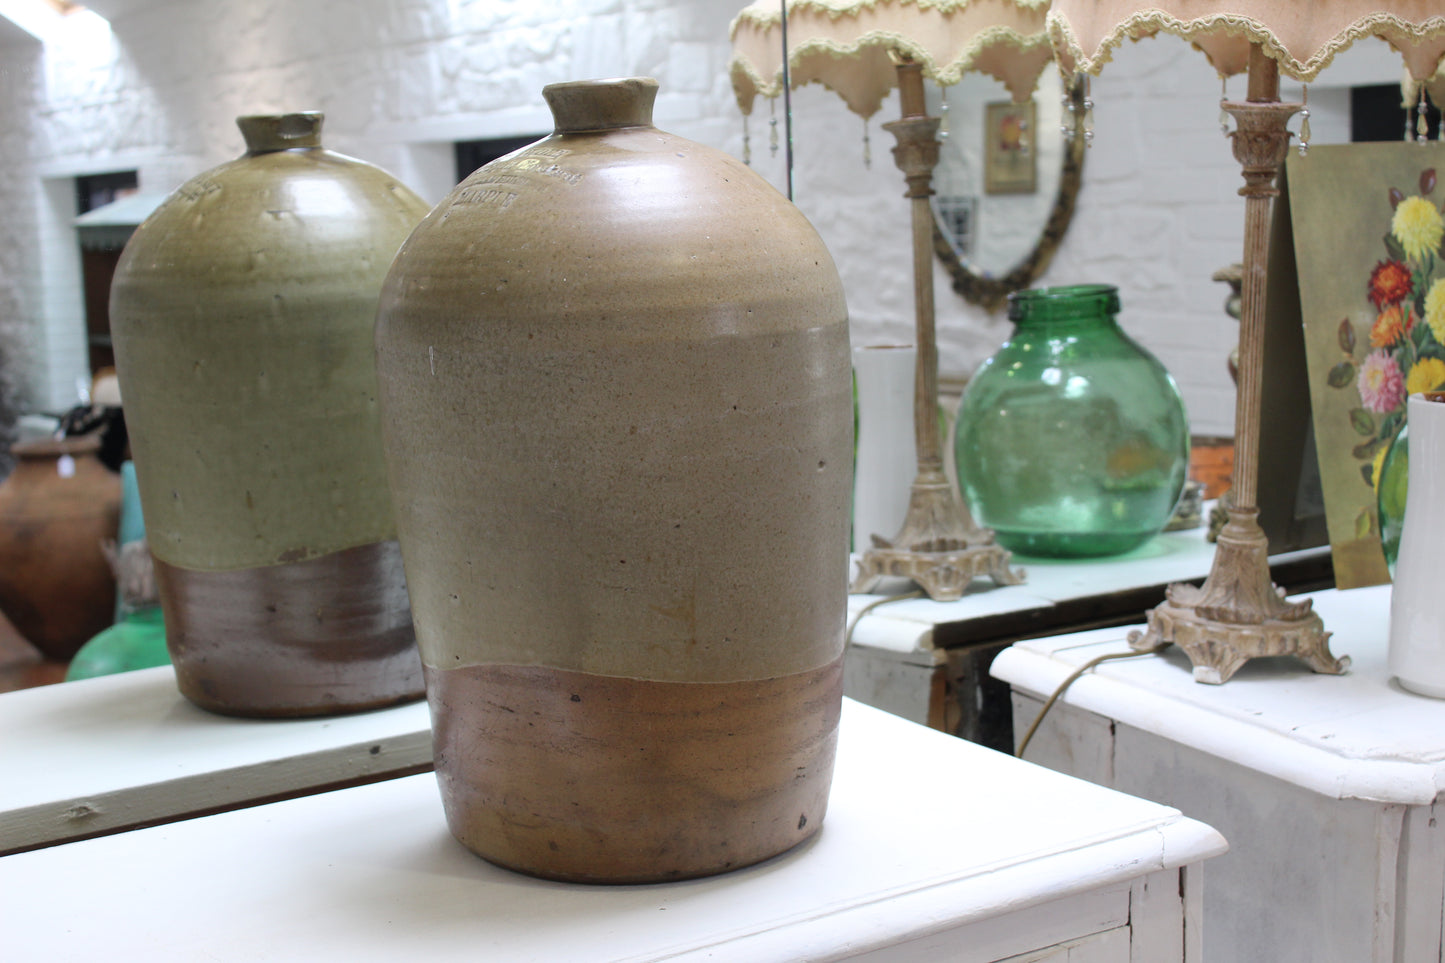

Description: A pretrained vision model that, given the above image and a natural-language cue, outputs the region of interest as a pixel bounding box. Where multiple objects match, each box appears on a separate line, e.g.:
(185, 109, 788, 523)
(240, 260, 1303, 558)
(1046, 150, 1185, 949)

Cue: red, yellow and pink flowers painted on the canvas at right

(1328, 168, 1445, 526)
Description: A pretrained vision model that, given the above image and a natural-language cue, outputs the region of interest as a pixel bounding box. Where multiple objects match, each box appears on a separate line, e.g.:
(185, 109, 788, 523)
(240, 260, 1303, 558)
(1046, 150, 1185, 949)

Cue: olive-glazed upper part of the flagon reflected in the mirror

(111, 114, 426, 571)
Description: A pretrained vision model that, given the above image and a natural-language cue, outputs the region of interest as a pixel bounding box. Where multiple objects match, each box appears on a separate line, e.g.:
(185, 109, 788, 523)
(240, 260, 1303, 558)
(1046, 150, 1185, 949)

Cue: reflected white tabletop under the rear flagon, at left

(0, 665, 432, 856)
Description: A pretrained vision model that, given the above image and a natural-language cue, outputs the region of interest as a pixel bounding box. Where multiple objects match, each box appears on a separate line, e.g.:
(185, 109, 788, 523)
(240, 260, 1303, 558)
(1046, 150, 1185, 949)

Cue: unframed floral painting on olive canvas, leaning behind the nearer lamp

(1287, 143, 1445, 587)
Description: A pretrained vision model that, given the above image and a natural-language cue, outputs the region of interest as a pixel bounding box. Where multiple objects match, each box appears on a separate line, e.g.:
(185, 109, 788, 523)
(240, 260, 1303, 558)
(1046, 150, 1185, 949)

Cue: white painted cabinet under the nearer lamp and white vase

(993, 586, 1445, 963)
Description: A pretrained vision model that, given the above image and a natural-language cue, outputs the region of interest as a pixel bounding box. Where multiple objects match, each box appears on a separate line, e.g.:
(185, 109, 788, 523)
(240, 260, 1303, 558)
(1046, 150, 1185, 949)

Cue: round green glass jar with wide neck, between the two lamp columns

(954, 285, 1189, 558)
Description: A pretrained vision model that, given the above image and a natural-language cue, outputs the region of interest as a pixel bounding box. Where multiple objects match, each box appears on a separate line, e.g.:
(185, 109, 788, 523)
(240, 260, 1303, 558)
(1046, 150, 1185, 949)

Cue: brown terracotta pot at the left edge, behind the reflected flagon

(0, 437, 120, 662)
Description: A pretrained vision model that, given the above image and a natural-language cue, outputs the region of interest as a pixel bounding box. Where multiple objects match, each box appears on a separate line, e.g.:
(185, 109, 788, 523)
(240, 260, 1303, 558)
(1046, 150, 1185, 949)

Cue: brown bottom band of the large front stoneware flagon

(426, 659, 842, 883)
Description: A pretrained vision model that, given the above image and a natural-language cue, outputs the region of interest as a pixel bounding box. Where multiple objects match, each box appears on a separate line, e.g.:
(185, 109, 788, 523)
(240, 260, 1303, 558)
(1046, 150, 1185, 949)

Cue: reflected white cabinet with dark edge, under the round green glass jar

(844, 505, 1334, 749)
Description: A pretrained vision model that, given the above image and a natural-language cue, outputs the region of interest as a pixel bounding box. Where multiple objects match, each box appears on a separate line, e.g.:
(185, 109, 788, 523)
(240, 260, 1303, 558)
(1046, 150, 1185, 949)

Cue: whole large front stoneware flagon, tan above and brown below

(377, 78, 851, 882)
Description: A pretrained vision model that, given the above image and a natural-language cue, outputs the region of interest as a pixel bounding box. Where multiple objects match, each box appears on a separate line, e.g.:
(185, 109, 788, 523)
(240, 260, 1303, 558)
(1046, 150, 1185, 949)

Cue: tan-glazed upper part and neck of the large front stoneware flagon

(377, 81, 853, 681)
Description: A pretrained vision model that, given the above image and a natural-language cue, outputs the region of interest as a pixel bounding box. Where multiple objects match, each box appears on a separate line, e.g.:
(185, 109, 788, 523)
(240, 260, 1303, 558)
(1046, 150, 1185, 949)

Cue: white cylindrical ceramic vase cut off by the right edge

(1390, 395, 1445, 698)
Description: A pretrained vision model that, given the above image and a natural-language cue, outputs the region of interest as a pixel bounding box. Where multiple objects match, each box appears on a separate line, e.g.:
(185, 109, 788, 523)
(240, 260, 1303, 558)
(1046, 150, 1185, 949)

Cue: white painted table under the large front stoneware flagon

(0, 700, 1224, 963)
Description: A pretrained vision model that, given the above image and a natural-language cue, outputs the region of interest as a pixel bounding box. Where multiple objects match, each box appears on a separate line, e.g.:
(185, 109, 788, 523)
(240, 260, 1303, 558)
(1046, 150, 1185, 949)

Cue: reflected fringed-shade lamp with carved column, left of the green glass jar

(730, 0, 1052, 602)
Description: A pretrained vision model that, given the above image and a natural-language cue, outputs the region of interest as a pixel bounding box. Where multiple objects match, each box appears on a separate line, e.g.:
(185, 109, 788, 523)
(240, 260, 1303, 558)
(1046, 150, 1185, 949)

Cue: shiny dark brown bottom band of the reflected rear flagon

(156, 541, 423, 716)
